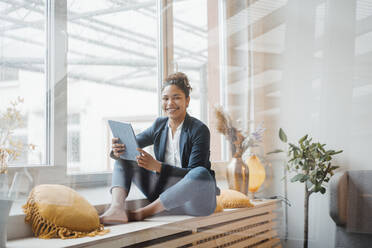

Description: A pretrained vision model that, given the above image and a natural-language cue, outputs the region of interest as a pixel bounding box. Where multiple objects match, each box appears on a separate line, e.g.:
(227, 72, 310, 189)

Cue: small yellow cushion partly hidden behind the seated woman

(217, 189, 253, 208)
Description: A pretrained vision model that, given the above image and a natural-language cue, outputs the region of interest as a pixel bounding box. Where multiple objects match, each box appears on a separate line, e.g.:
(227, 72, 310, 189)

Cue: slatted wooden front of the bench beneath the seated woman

(7, 200, 281, 248)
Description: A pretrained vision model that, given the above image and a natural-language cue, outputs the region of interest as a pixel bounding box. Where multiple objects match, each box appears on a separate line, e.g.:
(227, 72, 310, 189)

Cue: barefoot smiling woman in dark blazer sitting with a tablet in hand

(100, 72, 219, 224)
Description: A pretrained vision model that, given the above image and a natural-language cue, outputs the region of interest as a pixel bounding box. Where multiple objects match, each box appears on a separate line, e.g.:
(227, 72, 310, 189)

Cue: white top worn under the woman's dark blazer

(164, 121, 183, 168)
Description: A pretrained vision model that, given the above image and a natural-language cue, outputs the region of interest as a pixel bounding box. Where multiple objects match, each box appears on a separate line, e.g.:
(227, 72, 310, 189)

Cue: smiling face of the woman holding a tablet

(162, 85, 190, 121)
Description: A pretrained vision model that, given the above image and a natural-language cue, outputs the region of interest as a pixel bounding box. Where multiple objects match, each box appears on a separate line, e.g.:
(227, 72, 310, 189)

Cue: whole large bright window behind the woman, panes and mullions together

(0, 0, 225, 183)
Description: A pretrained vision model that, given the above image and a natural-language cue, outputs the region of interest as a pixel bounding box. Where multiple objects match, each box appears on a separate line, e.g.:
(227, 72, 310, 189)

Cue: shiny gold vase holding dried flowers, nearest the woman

(226, 157, 249, 195)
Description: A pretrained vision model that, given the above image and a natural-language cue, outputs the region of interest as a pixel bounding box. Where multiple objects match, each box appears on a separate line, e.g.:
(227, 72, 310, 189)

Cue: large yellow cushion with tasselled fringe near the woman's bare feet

(23, 184, 108, 239)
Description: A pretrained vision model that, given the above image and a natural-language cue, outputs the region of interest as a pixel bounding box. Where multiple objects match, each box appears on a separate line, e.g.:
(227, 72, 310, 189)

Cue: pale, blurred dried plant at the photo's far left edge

(0, 97, 35, 247)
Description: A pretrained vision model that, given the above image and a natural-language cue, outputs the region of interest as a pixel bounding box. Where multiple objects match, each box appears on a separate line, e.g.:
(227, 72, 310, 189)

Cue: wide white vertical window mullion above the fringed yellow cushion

(38, 0, 67, 183)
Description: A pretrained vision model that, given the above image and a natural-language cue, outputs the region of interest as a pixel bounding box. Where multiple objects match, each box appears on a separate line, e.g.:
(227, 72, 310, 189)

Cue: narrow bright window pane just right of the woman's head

(173, 0, 208, 122)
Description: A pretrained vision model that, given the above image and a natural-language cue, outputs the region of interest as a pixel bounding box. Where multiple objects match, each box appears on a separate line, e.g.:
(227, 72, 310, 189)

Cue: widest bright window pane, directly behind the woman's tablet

(67, 0, 158, 173)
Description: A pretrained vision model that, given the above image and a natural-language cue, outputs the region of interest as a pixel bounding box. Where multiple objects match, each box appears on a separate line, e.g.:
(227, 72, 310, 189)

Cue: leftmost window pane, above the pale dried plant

(0, 0, 46, 166)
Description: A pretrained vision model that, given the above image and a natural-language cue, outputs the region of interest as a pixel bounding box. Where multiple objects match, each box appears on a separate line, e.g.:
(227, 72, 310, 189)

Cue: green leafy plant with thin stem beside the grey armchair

(270, 128, 342, 248)
